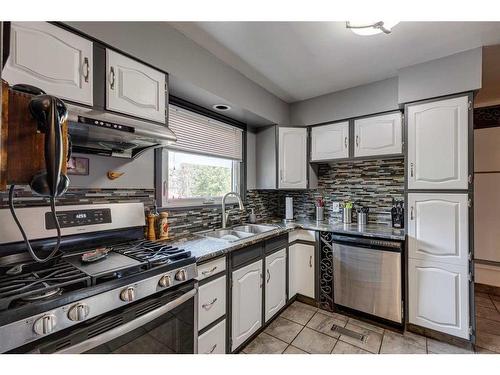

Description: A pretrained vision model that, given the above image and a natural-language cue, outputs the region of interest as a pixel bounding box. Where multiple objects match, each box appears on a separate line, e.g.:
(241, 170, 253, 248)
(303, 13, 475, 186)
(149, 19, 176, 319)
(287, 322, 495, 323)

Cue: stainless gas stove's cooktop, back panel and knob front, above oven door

(0, 203, 197, 352)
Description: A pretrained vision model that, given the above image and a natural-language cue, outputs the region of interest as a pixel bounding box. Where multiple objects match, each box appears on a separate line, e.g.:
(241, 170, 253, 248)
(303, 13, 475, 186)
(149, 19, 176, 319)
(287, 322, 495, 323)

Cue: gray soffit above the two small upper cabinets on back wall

(290, 77, 398, 126)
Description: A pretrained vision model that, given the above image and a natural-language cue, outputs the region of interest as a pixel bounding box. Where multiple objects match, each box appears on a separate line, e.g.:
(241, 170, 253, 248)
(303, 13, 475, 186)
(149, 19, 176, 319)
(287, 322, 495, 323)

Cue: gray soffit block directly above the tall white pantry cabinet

(398, 48, 482, 103)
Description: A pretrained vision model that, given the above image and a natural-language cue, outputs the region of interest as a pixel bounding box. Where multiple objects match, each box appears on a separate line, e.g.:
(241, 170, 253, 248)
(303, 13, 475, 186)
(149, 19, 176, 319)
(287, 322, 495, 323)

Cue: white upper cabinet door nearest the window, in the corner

(278, 128, 307, 189)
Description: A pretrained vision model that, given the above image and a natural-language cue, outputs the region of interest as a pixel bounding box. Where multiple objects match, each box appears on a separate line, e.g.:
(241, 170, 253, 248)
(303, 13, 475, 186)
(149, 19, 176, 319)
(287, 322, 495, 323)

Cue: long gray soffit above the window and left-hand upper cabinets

(66, 22, 289, 125)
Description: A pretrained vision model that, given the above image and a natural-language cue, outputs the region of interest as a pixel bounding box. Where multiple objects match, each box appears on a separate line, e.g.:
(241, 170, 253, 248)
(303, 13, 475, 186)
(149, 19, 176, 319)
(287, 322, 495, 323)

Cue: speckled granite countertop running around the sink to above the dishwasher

(169, 220, 405, 263)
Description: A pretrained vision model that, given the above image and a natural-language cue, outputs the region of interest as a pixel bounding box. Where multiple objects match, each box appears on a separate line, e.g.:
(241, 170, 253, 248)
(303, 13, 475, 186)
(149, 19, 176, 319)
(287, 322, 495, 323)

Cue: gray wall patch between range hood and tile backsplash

(69, 151, 154, 189)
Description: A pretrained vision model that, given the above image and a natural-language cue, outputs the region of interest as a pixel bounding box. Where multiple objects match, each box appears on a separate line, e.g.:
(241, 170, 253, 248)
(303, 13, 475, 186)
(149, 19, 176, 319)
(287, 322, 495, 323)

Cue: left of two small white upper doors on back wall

(311, 121, 349, 161)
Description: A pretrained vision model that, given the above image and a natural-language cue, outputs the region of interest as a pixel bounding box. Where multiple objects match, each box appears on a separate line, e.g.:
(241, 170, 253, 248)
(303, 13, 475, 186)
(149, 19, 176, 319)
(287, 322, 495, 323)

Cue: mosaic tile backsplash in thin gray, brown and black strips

(0, 159, 404, 237)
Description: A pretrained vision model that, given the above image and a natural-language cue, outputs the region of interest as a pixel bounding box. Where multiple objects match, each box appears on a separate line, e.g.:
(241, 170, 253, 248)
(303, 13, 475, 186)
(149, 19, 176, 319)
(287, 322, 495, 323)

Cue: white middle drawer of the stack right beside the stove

(198, 276, 226, 330)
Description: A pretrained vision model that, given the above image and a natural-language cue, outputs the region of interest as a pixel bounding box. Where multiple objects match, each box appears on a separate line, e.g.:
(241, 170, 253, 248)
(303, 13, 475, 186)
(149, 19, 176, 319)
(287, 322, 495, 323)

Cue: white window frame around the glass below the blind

(162, 149, 243, 208)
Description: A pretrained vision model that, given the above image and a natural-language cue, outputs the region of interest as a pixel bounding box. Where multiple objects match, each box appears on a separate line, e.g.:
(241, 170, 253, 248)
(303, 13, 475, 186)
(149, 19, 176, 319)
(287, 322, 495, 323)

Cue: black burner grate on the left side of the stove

(0, 260, 91, 311)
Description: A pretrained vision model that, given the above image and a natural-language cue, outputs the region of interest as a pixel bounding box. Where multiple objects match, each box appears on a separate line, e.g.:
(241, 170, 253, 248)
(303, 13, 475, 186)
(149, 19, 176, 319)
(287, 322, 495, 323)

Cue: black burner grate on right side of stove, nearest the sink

(113, 240, 191, 267)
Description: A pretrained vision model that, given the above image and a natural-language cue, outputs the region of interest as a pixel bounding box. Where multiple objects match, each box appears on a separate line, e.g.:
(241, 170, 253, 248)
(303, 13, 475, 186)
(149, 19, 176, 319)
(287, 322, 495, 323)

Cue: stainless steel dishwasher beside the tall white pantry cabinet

(332, 235, 403, 323)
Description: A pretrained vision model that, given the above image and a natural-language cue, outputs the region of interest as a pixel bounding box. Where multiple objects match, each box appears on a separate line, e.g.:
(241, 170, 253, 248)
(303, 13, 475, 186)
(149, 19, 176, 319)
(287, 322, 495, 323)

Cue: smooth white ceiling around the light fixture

(171, 22, 500, 102)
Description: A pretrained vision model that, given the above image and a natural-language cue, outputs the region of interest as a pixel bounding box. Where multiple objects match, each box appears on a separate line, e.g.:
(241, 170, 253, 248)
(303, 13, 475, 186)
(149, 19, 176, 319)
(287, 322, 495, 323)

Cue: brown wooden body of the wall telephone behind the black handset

(0, 81, 70, 191)
